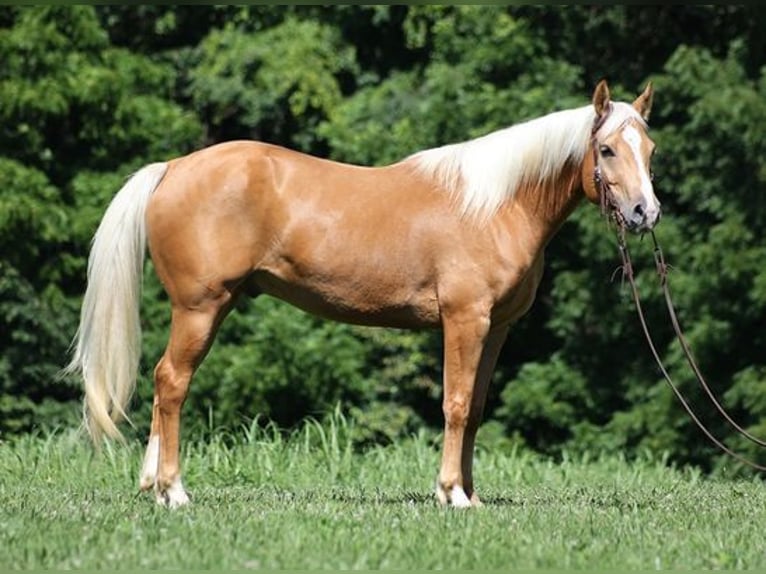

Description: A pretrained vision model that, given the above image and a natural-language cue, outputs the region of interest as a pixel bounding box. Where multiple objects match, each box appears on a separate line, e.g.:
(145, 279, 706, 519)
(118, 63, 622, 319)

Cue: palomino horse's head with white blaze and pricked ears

(583, 80, 660, 232)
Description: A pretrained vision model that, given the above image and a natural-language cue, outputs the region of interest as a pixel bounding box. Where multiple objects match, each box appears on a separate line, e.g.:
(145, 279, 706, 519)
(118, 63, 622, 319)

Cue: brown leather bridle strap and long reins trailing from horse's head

(591, 108, 766, 472)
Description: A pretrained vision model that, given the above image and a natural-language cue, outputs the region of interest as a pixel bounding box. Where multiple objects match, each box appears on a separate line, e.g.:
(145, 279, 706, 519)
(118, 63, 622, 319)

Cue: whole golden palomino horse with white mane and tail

(68, 81, 660, 506)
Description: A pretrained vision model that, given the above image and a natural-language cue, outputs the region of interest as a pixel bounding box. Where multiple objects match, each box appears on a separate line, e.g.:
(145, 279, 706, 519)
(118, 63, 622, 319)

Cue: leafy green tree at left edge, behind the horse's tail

(0, 6, 200, 431)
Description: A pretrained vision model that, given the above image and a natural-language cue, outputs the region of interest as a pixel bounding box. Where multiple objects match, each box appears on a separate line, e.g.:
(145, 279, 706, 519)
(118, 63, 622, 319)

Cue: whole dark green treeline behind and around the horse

(0, 6, 766, 474)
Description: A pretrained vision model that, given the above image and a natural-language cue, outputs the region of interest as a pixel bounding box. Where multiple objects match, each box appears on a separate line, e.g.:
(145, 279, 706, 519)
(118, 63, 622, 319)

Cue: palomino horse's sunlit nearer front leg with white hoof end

(436, 311, 490, 507)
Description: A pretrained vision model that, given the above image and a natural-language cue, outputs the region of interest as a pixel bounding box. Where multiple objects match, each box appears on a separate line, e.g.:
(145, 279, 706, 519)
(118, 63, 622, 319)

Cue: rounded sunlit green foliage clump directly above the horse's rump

(190, 18, 356, 149)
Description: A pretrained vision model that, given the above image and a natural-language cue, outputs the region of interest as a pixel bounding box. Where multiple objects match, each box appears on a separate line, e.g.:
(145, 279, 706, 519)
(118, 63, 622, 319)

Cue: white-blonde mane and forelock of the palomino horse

(412, 102, 644, 222)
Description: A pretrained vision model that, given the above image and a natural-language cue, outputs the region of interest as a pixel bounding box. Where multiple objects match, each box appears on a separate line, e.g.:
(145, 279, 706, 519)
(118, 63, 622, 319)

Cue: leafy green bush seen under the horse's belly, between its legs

(191, 299, 369, 426)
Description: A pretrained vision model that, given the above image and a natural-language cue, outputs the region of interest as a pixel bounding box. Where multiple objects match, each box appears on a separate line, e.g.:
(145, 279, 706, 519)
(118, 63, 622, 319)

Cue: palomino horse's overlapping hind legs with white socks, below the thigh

(141, 300, 229, 507)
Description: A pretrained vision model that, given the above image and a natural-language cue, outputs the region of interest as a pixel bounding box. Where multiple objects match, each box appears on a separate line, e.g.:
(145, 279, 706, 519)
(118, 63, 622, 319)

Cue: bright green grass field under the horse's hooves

(0, 418, 766, 569)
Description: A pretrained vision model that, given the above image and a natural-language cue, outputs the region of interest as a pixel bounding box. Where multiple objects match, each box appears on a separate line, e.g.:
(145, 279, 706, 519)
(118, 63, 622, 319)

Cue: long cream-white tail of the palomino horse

(65, 163, 168, 441)
